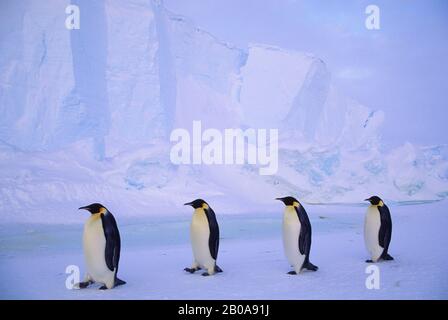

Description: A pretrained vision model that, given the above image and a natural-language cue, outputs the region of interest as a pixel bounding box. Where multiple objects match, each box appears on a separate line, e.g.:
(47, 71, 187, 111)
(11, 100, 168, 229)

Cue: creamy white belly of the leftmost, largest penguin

(83, 215, 115, 287)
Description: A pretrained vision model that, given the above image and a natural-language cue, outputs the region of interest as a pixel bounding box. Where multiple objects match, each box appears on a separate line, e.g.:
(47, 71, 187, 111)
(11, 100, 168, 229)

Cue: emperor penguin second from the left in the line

(184, 199, 222, 276)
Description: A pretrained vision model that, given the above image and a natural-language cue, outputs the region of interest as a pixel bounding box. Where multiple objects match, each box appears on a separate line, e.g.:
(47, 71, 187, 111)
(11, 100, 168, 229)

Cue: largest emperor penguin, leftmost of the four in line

(78, 203, 126, 290)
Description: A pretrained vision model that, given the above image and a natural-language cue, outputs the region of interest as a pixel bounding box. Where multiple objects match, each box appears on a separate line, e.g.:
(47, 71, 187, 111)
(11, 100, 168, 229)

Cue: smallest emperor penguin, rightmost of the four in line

(364, 196, 394, 263)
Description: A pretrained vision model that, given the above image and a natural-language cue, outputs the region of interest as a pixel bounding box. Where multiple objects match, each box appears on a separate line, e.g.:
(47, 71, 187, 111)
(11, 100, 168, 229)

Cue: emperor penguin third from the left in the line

(276, 197, 318, 275)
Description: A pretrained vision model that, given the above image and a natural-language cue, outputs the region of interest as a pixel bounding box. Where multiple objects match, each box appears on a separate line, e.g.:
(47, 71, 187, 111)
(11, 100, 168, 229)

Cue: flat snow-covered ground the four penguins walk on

(0, 200, 448, 299)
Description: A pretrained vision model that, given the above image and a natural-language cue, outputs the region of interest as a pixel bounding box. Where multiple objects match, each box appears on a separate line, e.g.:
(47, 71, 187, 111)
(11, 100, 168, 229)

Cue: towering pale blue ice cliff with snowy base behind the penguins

(0, 0, 448, 222)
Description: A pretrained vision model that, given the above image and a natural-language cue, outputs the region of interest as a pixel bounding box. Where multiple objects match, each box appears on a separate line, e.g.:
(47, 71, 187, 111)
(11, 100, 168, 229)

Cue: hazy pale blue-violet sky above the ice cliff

(165, 0, 448, 146)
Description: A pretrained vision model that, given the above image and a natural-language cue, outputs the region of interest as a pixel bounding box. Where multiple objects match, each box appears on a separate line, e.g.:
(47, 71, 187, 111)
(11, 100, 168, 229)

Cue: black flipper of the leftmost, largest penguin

(101, 212, 121, 273)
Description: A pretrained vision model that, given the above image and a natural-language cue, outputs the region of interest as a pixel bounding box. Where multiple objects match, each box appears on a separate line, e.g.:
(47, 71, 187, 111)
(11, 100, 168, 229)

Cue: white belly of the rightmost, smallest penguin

(364, 206, 383, 262)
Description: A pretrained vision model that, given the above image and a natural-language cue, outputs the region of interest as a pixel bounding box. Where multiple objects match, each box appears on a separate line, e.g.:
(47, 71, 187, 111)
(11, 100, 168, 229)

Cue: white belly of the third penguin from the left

(283, 206, 305, 272)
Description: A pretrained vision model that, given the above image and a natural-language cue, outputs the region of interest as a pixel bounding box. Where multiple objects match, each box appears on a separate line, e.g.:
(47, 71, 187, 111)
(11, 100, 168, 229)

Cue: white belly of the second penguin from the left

(190, 209, 215, 269)
